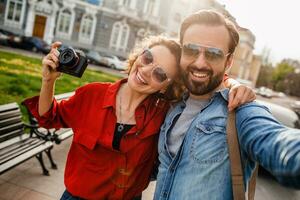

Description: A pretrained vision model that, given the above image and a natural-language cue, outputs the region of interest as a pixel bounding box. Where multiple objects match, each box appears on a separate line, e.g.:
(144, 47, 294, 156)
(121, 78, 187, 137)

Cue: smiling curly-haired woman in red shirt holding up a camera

(26, 37, 253, 199)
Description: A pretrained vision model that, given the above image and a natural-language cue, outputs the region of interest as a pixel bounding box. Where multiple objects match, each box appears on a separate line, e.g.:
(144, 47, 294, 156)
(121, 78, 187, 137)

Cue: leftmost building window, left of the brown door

(5, 0, 26, 27)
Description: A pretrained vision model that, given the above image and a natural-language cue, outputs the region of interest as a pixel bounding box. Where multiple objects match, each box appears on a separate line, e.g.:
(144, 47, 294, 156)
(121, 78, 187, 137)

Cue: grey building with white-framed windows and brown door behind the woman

(0, 0, 167, 57)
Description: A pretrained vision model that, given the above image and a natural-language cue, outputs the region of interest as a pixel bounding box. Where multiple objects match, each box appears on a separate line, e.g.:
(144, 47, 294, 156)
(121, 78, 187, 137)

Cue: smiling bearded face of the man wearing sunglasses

(180, 24, 232, 95)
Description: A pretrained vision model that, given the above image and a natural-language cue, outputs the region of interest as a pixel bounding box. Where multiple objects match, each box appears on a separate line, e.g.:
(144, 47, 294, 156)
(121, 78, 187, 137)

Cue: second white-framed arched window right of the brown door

(79, 14, 96, 44)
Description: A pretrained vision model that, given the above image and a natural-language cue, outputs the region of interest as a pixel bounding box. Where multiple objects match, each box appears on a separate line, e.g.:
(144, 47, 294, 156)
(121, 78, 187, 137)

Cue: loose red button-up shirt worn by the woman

(25, 79, 169, 200)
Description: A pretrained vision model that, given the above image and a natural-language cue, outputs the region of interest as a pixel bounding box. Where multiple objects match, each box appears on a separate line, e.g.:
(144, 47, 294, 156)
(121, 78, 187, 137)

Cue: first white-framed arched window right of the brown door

(57, 8, 75, 39)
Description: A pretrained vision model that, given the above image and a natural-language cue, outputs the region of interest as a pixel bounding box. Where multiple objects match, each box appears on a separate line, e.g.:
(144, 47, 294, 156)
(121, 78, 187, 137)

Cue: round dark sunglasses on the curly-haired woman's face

(140, 49, 172, 83)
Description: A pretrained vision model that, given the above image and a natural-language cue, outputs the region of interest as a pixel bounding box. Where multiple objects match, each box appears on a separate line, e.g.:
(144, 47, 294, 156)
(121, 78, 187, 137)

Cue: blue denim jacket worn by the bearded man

(154, 89, 300, 200)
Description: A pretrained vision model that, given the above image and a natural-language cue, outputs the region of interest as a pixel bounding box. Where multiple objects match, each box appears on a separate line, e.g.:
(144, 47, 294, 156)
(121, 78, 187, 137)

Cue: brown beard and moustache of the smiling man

(181, 66, 225, 96)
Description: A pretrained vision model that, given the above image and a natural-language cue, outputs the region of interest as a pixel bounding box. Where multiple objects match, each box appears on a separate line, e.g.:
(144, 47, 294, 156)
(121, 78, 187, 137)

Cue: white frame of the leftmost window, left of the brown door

(4, 0, 26, 28)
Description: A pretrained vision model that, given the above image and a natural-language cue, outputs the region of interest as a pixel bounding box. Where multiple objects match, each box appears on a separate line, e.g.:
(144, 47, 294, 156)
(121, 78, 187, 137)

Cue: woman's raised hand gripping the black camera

(42, 42, 61, 82)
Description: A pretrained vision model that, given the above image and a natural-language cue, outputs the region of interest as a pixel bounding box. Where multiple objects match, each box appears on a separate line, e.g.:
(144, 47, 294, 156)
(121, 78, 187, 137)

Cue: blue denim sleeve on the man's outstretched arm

(236, 103, 300, 188)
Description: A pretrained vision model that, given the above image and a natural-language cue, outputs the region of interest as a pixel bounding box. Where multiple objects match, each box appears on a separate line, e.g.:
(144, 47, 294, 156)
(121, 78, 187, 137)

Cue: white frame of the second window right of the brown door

(79, 13, 97, 44)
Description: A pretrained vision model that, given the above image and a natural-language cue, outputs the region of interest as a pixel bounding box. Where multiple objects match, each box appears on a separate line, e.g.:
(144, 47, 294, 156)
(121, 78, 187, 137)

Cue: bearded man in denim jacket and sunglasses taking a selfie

(154, 11, 300, 200)
